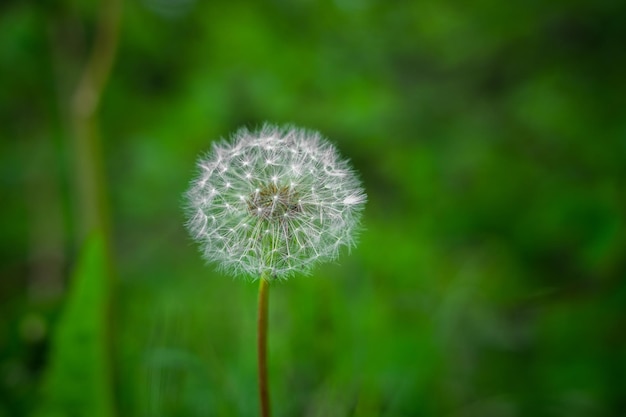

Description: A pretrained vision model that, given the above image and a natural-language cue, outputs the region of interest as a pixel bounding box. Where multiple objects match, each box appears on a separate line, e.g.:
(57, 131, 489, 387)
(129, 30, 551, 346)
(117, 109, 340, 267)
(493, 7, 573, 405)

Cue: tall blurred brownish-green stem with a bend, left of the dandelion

(69, 0, 122, 417)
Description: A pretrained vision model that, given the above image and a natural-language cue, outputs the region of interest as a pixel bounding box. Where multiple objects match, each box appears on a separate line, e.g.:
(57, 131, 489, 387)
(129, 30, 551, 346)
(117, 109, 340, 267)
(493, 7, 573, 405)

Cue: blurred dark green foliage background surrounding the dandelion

(0, 0, 626, 417)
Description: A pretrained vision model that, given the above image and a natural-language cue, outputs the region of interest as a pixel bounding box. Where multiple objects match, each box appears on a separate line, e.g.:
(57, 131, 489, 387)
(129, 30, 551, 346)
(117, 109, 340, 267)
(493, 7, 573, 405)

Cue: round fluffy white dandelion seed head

(186, 124, 367, 279)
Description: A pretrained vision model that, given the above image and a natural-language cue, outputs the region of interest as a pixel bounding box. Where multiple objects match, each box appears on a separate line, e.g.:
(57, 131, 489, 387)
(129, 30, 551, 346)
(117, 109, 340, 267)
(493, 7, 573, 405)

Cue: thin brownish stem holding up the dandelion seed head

(257, 274, 270, 417)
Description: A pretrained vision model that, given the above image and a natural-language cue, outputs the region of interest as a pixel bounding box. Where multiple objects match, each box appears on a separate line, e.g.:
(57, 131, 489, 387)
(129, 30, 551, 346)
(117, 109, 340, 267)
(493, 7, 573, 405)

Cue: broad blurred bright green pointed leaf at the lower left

(36, 234, 114, 417)
